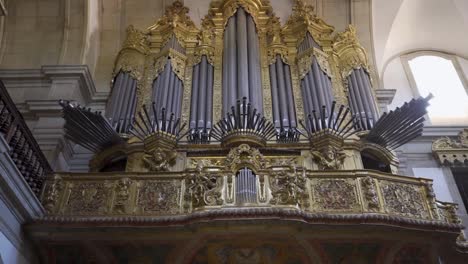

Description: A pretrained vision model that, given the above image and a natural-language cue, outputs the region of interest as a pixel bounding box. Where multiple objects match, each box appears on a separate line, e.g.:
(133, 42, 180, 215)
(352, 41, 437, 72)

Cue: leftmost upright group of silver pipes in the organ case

(106, 72, 137, 133)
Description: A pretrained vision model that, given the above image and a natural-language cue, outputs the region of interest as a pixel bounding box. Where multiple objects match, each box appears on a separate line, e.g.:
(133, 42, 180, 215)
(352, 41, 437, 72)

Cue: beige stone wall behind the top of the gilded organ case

(0, 0, 373, 91)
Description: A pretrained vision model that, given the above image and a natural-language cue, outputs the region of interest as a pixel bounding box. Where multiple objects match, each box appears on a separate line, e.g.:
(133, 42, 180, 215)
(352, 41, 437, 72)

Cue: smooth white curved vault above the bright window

(372, 0, 468, 74)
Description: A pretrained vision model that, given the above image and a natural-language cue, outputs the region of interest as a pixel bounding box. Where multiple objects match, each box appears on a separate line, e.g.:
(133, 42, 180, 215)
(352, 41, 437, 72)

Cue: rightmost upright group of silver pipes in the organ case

(347, 68, 378, 130)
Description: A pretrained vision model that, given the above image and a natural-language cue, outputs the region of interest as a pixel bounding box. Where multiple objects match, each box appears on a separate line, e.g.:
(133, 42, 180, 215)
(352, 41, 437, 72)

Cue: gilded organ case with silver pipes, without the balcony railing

(62, 0, 428, 182)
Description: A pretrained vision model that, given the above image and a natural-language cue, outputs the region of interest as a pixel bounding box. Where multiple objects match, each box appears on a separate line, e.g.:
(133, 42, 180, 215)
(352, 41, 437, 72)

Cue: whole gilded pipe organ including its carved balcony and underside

(41, 0, 468, 263)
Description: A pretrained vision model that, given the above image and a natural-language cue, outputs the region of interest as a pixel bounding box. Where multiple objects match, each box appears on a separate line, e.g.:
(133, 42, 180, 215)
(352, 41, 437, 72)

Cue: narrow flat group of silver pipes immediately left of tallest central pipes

(190, 56, 214, 139)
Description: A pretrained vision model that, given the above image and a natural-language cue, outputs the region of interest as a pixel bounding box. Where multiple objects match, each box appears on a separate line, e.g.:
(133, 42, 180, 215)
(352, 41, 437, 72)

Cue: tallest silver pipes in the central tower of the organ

(223, 8, 263, 115)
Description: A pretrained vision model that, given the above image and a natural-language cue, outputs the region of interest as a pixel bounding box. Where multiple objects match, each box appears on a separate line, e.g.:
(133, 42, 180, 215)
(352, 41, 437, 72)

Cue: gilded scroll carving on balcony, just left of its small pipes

(185, 170, 223, 208)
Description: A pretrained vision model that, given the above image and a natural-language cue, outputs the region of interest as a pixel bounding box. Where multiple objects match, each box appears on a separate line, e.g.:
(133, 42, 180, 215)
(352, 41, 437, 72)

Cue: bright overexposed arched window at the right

(408, 55, 468, 124)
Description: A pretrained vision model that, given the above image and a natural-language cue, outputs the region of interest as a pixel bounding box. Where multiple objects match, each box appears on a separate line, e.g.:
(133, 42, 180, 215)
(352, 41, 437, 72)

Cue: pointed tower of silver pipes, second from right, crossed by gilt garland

(298, 33, 334, 125)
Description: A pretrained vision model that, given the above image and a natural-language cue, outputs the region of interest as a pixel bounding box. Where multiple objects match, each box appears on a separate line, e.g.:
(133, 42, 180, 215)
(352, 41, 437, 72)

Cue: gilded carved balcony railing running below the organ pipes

(42, 167, 460, 229)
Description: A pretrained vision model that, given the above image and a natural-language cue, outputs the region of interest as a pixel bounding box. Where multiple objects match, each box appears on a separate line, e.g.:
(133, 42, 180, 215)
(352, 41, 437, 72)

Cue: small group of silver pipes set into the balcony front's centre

(236, 168, 257, 205)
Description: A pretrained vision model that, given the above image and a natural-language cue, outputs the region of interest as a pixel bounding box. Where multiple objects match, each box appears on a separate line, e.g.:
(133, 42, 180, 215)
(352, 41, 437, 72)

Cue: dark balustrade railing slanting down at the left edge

(0, 81, 52, 197)
